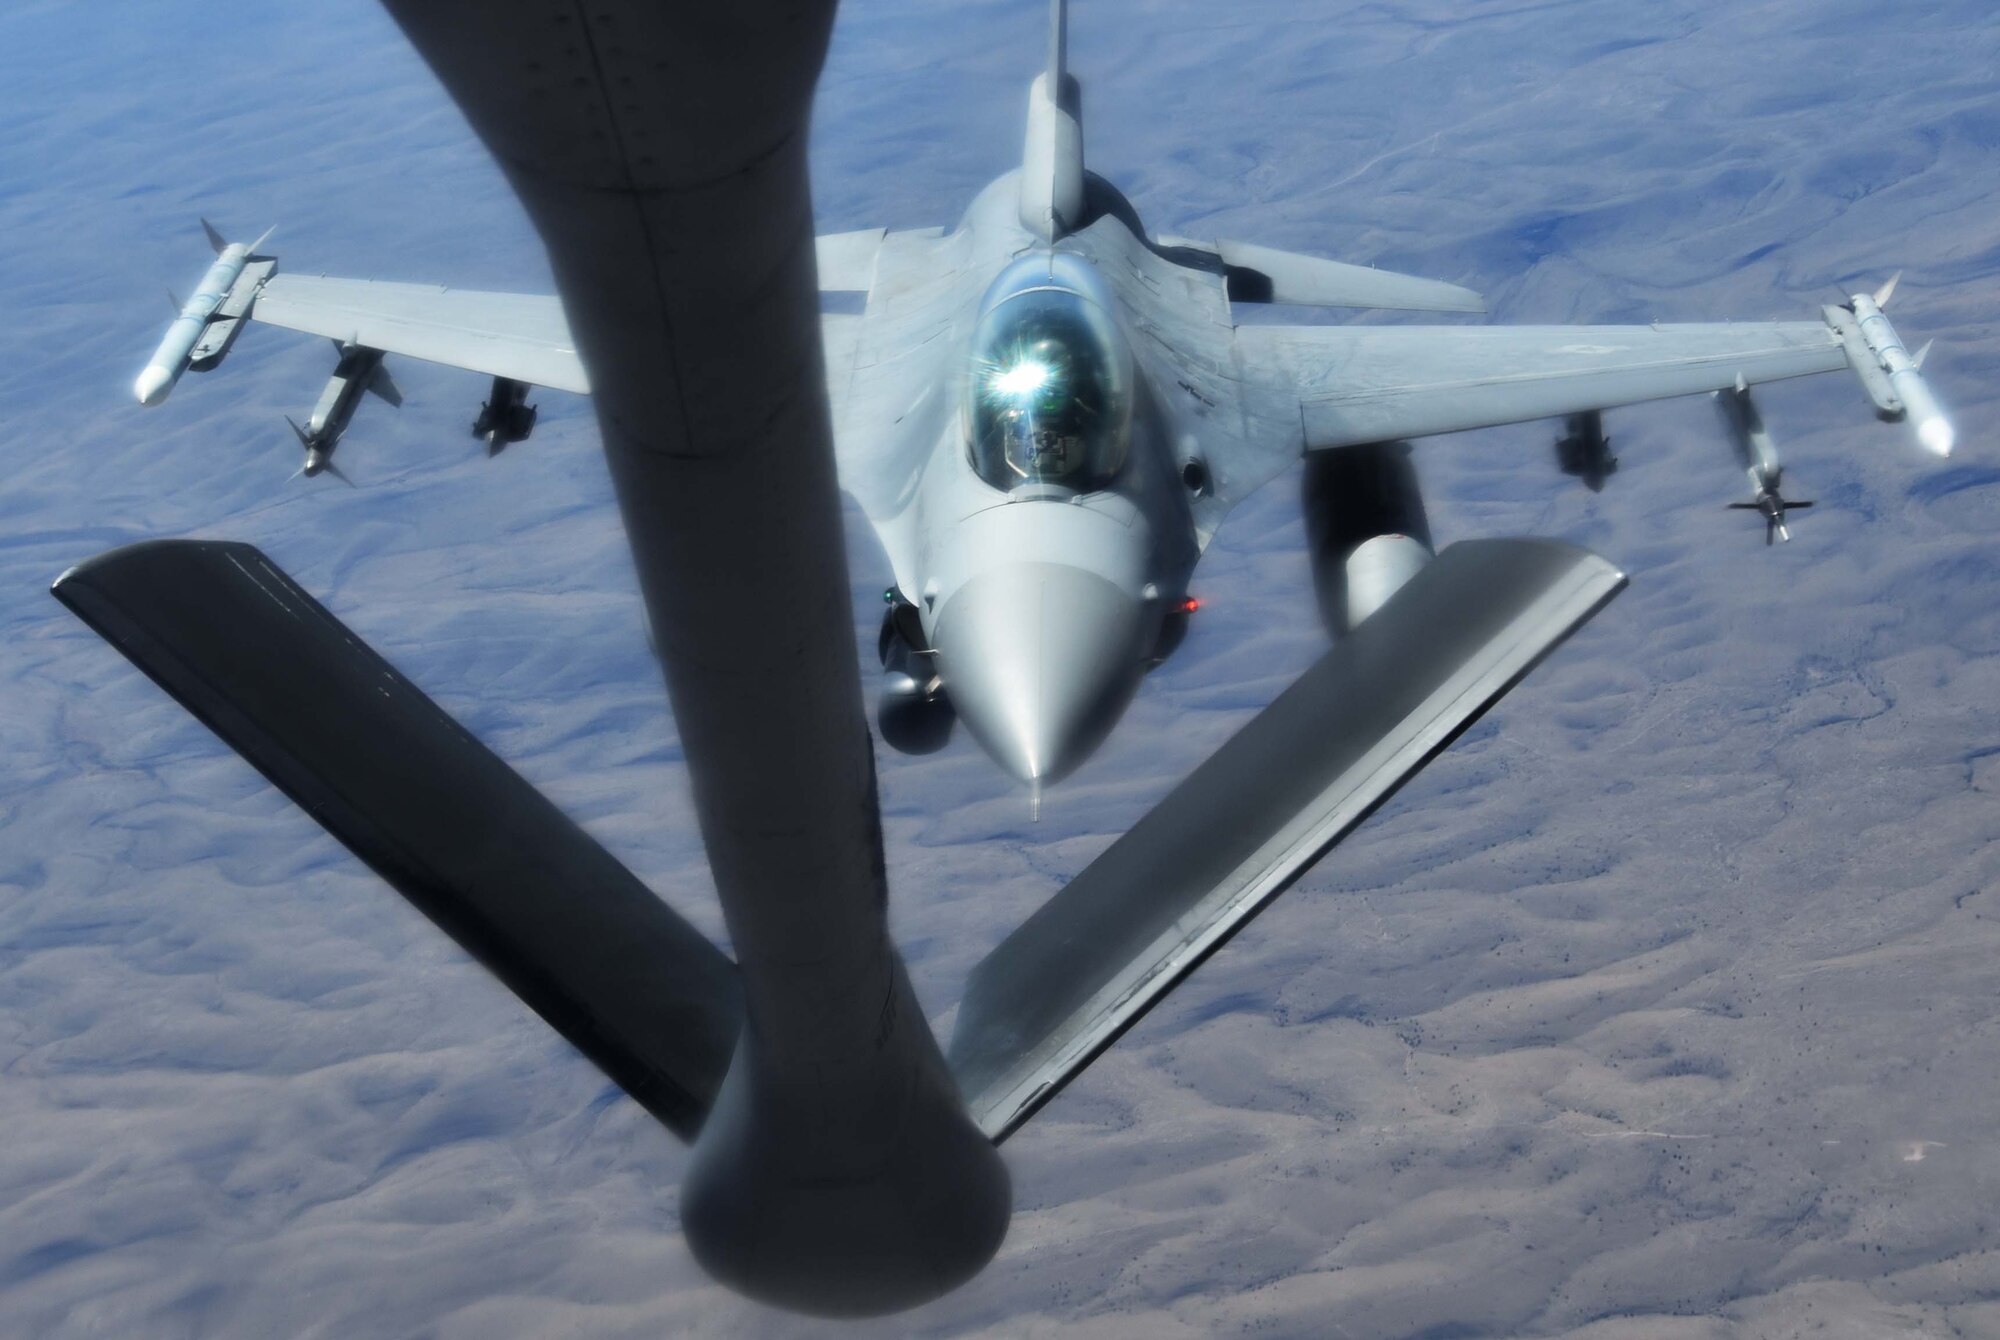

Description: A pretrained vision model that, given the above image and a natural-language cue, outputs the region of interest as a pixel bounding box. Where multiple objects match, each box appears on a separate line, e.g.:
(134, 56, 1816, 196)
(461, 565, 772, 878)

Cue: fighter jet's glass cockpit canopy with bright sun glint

(966, 252, 1132, 490)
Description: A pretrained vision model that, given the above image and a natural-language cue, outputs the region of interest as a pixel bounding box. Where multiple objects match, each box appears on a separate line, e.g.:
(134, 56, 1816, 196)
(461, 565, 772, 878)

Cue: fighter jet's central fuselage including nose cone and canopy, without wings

(896, 174, 1200, 788)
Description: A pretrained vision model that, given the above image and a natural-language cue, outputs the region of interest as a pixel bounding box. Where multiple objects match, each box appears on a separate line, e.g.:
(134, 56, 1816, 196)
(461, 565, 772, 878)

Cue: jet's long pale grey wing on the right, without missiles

(1236, 322, 1848, 450)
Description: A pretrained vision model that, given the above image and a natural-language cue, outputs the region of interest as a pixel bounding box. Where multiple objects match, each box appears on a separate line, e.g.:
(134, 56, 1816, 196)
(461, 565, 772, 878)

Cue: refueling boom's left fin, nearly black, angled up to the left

(54, 540, 742, 1138)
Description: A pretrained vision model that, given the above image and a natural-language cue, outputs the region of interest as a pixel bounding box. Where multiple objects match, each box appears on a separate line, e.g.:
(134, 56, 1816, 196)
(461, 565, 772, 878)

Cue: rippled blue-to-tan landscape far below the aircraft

(0, 0, 2000, 1340)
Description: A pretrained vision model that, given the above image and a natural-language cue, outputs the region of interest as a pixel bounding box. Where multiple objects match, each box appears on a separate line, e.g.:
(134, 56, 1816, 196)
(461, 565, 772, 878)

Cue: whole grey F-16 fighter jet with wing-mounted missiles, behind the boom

(117, 6, 1952, 788)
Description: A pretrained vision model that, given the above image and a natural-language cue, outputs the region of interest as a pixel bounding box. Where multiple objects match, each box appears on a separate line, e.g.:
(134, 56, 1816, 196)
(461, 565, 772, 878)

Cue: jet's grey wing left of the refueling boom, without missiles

(250, 274, 590, 394)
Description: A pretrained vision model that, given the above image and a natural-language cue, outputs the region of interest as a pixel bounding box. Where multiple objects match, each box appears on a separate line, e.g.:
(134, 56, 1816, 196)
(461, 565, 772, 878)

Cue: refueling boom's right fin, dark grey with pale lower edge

(950, 540, 1624, 1140)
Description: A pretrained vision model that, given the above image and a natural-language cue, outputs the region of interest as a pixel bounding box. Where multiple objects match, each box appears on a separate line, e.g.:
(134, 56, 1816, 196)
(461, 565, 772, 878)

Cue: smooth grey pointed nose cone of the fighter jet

(934, 562, 1146, 784)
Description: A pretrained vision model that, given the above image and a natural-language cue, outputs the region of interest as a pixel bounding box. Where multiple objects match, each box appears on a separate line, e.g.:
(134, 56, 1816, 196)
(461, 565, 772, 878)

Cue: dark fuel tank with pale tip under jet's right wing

(1302, 442, 1432, 638)
